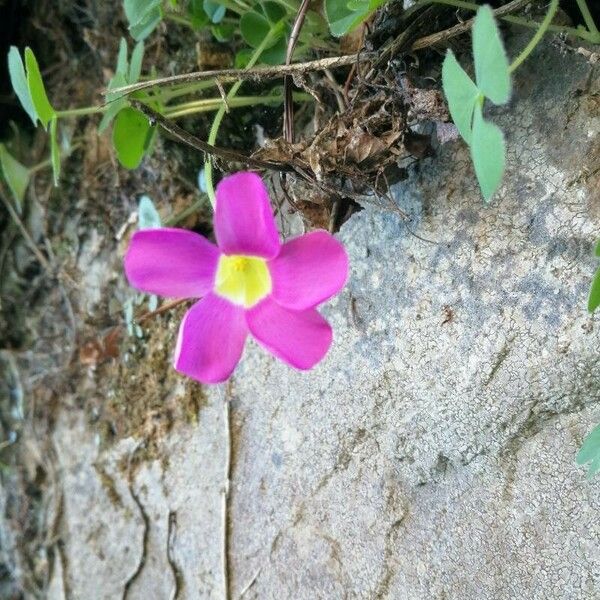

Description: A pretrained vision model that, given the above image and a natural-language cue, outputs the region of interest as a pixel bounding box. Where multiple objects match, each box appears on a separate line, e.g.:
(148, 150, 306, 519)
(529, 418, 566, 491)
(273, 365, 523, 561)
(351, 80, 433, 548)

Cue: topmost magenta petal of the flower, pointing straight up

(214, 172, 280, 258)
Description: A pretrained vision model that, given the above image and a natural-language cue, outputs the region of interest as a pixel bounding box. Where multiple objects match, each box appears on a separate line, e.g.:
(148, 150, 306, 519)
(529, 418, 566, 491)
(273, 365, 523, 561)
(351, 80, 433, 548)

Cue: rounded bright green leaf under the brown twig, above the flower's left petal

(113, 106, 154, 169)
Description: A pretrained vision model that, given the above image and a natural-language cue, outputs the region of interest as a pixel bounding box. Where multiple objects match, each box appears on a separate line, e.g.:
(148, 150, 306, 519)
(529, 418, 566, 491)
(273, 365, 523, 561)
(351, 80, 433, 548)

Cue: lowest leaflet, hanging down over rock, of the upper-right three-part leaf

(471, 102, 505, 202)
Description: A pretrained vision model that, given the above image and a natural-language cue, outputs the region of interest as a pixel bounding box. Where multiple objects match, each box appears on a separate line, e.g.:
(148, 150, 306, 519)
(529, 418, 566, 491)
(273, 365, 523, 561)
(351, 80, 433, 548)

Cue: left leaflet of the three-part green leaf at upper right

(442, 50, 480, 145)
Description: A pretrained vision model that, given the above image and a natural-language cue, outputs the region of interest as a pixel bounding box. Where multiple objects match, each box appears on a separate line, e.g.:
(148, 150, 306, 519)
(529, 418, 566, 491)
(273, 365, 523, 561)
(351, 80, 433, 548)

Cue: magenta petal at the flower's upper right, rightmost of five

(269, 230, 348, 310)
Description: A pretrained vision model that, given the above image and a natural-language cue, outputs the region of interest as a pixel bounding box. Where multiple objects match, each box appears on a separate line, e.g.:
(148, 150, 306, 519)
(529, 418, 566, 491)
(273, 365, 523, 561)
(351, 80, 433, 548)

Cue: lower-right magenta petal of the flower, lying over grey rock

(246, 298, 333, 370)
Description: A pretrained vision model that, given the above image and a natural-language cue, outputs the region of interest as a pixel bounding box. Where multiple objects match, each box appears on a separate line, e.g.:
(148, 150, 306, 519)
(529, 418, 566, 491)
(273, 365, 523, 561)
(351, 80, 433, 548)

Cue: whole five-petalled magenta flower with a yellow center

(125, 173, 348, 383)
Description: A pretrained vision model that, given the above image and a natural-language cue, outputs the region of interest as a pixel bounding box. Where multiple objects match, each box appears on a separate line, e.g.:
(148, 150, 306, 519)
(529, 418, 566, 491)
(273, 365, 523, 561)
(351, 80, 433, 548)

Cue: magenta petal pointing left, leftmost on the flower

(125, 228, 220, 298)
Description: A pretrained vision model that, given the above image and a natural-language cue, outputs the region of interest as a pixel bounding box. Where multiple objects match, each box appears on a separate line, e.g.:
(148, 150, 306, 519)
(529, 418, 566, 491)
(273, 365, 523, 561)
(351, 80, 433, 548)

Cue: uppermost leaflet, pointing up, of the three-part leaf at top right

(473, 5, 510, 104)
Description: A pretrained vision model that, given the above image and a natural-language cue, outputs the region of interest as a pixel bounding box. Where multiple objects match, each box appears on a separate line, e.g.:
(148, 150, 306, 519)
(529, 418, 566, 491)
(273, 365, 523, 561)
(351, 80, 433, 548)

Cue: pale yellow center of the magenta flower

(215, 254, 272, 308)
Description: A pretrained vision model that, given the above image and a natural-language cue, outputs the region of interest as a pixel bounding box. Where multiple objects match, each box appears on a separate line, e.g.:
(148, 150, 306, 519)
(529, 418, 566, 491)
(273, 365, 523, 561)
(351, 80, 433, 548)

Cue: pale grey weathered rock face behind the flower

(52, 39, 600, 600)
